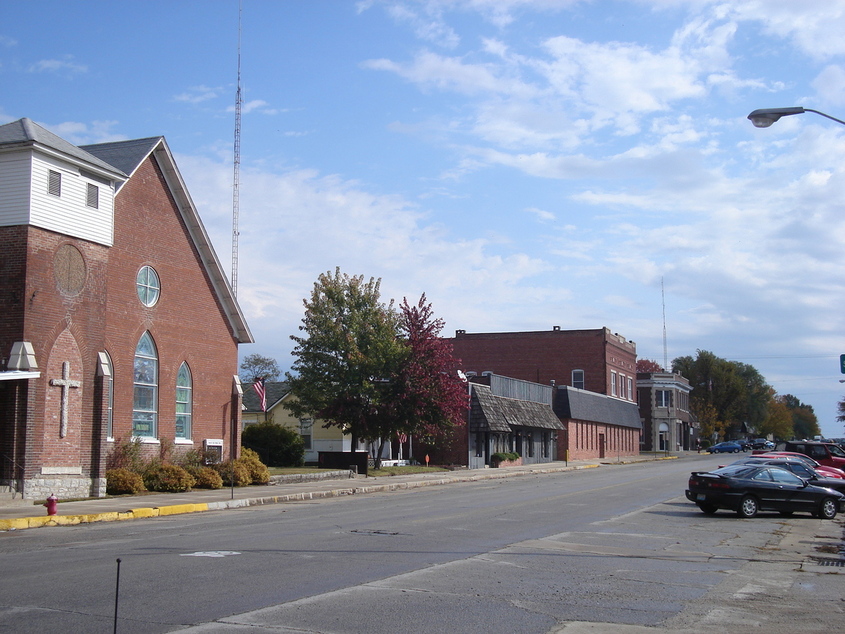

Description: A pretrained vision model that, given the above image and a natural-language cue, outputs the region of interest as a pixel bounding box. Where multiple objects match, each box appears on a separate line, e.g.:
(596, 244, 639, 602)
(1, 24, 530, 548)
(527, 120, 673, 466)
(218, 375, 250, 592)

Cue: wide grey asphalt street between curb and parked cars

(0, 454, 843, 634)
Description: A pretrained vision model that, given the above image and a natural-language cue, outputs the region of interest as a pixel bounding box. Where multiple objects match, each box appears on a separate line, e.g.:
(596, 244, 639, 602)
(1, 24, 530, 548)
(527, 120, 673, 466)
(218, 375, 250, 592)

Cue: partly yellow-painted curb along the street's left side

(0, 460, 628, 531)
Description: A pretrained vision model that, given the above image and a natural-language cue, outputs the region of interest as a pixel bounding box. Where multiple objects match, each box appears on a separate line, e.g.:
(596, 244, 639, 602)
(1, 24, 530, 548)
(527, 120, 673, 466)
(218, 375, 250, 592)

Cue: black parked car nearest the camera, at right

(686, 464, 845, 519)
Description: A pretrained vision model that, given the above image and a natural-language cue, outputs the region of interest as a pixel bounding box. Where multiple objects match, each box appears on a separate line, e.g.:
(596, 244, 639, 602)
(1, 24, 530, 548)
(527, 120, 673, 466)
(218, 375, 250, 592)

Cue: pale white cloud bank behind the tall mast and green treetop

(178, 156, 552, 351)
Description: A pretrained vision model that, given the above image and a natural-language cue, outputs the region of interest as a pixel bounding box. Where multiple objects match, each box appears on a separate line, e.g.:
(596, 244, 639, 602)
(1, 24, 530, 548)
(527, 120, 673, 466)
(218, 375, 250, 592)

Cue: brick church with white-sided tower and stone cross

(0, 119, 253, 498)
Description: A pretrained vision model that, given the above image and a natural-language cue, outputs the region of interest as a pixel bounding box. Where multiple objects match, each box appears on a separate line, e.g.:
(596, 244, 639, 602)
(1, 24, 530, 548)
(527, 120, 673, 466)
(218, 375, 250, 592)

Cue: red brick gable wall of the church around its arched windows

(105, 158, 239, 453)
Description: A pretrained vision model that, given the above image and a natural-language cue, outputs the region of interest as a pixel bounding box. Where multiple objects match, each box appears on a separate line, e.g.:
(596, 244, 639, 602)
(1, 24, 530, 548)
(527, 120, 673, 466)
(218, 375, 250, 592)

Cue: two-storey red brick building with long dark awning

(448, 327, 642, 460)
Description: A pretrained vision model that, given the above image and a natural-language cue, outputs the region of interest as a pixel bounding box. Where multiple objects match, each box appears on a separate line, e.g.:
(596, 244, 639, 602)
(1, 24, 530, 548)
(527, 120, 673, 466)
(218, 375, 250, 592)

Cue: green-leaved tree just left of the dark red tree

(284, 268, 407, 454)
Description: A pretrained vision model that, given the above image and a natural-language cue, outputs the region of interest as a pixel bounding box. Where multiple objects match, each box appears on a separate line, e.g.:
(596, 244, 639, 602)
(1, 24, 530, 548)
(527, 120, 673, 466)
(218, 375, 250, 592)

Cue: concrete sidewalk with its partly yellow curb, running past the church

(0, 454, 678, 531)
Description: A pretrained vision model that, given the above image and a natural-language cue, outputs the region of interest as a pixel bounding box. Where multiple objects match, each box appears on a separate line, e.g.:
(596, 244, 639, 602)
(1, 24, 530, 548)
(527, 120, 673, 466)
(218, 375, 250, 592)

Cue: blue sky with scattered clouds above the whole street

(0, 0, 845, 436)
